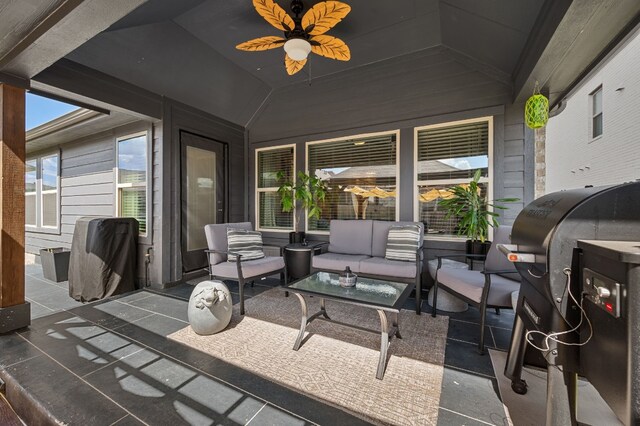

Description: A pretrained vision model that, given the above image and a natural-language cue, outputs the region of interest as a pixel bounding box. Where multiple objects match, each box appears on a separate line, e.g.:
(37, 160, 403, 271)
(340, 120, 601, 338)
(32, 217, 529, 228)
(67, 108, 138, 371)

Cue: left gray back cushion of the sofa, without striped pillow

(329, 220, 372, 256)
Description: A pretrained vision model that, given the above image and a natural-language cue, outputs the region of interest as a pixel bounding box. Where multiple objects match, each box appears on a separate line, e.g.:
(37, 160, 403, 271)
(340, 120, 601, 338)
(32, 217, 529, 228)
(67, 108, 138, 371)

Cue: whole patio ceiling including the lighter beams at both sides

(0, 0, 640, 126)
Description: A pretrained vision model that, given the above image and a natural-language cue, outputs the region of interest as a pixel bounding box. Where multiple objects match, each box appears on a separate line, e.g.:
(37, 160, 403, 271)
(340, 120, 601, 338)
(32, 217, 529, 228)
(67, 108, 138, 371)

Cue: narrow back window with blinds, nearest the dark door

(256, 145, 295, 231)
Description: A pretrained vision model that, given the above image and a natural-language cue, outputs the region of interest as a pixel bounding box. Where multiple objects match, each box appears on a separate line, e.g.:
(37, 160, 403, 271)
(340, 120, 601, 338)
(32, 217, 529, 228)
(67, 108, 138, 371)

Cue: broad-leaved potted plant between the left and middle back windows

(276, 171, 327, 243)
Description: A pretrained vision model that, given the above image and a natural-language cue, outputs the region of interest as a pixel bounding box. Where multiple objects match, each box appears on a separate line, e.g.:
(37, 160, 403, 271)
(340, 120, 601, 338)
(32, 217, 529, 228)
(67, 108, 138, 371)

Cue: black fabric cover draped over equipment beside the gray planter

(69, 217, 138, 302)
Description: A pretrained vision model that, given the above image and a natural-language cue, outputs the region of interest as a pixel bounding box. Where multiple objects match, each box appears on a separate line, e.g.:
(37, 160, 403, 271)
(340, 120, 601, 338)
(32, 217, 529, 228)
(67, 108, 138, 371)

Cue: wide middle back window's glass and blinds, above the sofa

(307, 132, 398, 231)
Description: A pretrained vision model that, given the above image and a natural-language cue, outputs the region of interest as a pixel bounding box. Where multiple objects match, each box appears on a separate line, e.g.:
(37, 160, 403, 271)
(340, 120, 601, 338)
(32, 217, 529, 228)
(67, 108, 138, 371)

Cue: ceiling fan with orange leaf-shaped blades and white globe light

(236, 0, 351, 75)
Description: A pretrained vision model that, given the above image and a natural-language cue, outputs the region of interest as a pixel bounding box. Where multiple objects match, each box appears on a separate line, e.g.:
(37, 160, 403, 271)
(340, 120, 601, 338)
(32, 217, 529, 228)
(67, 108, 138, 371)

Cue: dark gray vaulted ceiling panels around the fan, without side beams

(62, 0, 543, 125)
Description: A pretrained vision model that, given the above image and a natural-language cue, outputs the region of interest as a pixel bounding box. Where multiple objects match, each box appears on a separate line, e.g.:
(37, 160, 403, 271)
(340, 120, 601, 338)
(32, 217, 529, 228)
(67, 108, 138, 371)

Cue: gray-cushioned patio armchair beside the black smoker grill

(431, 226, 520, 354)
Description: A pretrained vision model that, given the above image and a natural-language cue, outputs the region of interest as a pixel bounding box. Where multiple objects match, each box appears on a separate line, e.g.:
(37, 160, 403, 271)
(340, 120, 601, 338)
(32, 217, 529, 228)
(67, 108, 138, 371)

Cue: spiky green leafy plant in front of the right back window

(439, 169, 520, 243)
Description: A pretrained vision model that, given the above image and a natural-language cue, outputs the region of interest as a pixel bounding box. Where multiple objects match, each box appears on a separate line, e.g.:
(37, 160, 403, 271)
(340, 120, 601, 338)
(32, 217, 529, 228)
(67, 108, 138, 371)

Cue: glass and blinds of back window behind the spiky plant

(415, 118, 492, 236)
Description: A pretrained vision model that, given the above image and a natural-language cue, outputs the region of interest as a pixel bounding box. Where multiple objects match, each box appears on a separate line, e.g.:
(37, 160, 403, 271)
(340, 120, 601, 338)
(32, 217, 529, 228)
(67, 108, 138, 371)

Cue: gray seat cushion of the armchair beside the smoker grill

(438, 268, 520, 307)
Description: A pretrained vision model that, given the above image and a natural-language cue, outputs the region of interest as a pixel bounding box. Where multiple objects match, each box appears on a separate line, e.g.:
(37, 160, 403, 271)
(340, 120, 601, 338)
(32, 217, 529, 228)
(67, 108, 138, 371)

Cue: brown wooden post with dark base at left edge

(0, 84, 31, 333)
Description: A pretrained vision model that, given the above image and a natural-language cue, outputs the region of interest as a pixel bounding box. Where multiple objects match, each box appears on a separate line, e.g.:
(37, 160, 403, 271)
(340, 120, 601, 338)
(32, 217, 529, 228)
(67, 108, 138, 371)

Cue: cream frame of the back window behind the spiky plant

(413, 116, 494, 241)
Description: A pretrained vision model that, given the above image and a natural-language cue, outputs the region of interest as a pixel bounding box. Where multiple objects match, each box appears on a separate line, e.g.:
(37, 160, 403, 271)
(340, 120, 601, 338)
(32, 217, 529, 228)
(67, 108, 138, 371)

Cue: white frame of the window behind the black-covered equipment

(113, 127, 153, 244)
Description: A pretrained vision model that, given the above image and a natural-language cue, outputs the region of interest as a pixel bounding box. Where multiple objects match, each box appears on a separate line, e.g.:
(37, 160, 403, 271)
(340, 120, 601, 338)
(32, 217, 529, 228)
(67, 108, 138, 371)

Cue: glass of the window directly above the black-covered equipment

(117, 132, 148, 237)
